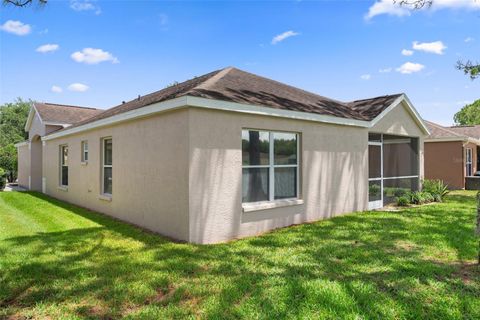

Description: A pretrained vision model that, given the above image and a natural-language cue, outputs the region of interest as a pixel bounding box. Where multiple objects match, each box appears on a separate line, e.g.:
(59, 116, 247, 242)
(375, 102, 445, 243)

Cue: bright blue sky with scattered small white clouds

(0, 0, 480, 125)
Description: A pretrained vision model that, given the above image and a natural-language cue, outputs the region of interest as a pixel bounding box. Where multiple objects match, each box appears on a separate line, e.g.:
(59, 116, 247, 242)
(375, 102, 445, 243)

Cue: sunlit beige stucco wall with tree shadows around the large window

(189, 109, 368, 243)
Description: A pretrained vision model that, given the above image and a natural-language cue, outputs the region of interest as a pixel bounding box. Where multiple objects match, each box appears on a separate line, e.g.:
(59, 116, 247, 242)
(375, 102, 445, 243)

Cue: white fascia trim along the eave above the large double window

(187, 96, 369, 128)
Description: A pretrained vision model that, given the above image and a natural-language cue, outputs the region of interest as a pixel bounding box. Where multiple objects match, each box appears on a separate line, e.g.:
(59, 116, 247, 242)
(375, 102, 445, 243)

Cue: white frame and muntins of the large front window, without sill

(242, 128, 300, 203)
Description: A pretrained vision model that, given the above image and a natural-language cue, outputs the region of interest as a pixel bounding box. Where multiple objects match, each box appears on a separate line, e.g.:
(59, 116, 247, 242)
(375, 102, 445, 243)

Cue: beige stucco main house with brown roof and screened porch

(15, 68, 429, 243)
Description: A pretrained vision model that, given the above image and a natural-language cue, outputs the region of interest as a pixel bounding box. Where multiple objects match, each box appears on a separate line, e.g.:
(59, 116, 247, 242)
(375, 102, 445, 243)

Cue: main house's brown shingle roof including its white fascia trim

(43, 67, 428, 140)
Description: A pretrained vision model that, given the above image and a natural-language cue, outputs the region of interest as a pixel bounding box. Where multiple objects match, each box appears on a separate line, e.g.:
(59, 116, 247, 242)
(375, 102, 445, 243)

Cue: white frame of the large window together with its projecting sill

(242, 128, 303, 205)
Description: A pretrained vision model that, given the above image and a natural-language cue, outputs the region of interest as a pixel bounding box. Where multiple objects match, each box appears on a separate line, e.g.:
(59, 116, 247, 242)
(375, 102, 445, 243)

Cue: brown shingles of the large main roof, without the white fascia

(62, 67, 400, 131)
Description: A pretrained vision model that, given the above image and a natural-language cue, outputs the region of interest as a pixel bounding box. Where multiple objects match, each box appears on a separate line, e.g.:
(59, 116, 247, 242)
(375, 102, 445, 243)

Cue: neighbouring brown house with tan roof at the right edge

(425, 121, 480, 189)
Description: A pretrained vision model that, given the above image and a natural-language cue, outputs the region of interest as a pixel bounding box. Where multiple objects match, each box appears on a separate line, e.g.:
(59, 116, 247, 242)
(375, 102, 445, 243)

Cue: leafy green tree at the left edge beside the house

(0, 98, 31, 182)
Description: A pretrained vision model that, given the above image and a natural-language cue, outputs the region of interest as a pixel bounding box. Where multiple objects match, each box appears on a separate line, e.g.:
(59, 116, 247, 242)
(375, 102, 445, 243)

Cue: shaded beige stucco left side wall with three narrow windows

(44, 110, 189, 240)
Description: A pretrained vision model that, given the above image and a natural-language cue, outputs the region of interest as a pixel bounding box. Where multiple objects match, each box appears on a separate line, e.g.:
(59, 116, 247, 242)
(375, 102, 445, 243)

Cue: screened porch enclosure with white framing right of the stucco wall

(368, 133, 419, 209)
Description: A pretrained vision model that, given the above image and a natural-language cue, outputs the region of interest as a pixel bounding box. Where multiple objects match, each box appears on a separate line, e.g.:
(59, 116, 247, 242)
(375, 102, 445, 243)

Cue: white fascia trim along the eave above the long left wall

(42, 97, 187, 141)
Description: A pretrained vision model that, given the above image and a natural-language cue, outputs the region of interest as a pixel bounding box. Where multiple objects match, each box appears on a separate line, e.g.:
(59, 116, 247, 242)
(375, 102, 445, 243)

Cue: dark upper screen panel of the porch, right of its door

(383, 135, 418, 177)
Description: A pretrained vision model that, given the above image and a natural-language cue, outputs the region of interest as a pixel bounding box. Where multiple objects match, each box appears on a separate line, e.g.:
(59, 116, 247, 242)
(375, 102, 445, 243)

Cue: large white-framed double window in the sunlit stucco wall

(242, 130, 299, 203)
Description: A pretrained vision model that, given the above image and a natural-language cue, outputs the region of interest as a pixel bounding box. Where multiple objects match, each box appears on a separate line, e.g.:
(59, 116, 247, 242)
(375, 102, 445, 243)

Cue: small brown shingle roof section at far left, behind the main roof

(34, 102, 103, 124)
